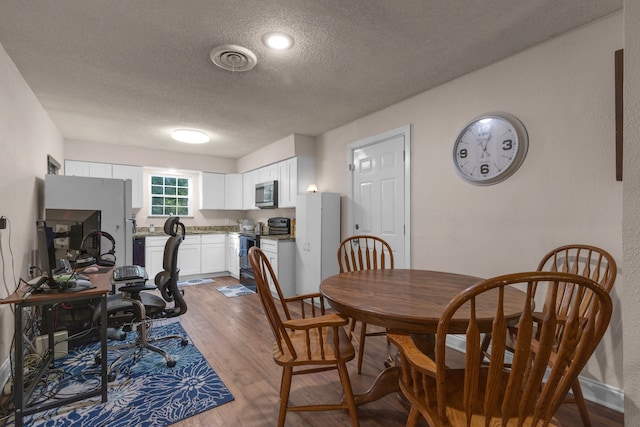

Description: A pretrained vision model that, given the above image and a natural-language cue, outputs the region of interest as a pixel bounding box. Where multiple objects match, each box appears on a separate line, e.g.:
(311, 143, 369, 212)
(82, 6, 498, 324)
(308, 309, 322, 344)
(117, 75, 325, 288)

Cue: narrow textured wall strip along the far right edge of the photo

(622, 0, 640, 426)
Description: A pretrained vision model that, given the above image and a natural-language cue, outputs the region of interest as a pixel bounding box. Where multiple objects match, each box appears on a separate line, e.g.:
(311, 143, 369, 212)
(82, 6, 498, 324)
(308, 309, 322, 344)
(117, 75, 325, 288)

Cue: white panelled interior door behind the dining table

(349, 126, 410, 268)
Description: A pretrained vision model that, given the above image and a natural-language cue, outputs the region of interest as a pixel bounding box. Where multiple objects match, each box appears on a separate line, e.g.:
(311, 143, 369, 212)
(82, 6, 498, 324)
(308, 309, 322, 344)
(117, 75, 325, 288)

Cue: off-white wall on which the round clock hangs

(316, 13, 623, 398)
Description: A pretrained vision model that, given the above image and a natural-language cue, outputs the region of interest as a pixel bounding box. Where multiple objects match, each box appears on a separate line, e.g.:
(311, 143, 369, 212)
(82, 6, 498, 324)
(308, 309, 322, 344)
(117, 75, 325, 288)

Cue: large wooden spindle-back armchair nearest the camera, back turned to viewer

(388, 271, 612, 427)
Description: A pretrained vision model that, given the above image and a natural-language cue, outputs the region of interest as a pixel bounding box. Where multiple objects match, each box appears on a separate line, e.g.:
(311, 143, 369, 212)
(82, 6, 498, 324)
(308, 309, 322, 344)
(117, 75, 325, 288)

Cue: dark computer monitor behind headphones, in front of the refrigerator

(45, 209, 102, 265)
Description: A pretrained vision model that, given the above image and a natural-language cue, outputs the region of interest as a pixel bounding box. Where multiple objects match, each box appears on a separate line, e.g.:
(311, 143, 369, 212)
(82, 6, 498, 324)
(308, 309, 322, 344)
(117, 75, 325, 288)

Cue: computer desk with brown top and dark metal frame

(0, 269, 113, 427)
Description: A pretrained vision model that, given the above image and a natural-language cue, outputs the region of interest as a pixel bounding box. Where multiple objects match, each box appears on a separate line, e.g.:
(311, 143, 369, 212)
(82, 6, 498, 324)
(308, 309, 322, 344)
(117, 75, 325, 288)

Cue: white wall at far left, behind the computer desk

(0, 45, 63, 374)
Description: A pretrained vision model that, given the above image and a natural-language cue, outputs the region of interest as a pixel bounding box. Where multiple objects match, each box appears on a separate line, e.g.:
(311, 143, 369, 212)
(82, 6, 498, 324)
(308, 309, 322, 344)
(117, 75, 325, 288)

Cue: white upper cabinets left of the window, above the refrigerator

(64, 160, 143, 209)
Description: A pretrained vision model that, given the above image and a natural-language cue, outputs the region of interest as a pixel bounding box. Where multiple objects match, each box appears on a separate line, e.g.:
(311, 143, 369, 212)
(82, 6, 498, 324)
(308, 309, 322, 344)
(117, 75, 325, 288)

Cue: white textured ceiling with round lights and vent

(0, 0, 623, 158)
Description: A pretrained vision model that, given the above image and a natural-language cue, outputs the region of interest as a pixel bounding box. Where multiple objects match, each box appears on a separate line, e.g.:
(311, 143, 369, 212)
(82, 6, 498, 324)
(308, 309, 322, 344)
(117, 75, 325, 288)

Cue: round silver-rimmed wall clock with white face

(453, 113, 529, 185)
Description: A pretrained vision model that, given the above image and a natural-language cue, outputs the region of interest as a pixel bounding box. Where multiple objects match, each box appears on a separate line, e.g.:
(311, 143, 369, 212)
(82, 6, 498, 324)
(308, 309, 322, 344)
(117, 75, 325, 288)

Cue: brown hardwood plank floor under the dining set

(175, 277, 624, 427)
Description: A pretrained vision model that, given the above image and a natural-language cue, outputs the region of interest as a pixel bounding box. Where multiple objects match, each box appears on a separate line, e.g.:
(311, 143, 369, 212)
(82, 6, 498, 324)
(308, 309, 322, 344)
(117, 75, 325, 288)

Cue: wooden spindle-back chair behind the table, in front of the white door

(338, 235, 393, 373)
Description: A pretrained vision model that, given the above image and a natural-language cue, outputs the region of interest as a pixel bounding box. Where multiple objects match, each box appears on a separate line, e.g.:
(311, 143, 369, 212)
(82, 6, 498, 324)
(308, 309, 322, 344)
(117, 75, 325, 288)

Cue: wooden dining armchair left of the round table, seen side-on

(249, 247, 359, 427)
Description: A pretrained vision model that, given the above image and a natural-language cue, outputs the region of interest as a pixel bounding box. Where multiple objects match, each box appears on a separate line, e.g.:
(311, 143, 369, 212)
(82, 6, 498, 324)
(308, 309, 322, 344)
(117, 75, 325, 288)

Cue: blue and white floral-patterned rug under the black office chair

(19, 322, 233, 427)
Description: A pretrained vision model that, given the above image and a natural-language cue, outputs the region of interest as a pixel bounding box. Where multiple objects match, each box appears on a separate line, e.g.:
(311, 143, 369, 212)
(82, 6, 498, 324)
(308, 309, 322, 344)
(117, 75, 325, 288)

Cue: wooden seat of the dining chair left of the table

(273, 318, 355, 366)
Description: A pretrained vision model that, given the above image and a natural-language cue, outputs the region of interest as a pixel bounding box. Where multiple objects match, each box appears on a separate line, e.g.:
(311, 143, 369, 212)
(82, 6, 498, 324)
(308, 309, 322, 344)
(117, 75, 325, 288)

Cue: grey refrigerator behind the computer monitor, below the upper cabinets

(44, 175, 134, 265)
